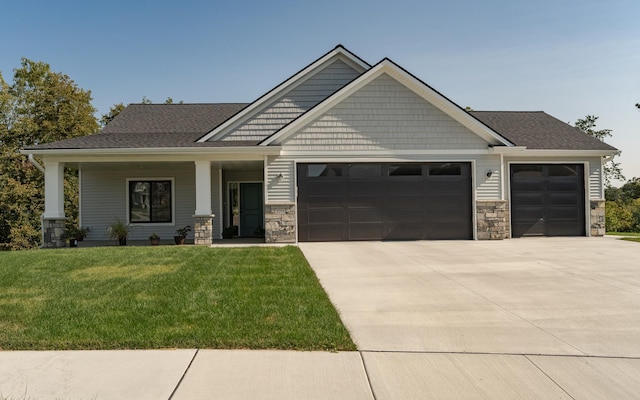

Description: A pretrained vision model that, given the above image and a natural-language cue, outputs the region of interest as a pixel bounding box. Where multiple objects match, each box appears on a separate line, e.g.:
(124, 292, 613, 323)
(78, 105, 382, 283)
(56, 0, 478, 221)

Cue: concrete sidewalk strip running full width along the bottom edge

(0, 350, 640, 400)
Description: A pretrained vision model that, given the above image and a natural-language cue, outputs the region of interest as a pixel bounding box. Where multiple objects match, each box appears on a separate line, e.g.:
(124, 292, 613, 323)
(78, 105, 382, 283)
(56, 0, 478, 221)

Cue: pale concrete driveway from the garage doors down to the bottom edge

(300, 238, 640, 399)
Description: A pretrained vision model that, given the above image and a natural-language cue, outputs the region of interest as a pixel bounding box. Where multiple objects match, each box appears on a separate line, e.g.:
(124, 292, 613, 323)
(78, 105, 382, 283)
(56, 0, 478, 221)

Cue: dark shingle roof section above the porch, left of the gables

(27, 103, 252, 150)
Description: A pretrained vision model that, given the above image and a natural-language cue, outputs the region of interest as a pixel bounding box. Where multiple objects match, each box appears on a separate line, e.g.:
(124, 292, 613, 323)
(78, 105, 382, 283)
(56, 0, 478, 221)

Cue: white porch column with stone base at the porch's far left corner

(42, 160, 66, 248)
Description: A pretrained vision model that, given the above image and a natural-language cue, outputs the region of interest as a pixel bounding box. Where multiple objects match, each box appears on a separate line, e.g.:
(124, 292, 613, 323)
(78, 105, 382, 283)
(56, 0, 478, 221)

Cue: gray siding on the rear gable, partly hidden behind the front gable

(223, 60, 359, 140)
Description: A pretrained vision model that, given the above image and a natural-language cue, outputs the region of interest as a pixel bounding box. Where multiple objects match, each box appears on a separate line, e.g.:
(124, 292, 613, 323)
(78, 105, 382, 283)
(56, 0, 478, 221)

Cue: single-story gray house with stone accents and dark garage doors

(23, 46, 617, 247)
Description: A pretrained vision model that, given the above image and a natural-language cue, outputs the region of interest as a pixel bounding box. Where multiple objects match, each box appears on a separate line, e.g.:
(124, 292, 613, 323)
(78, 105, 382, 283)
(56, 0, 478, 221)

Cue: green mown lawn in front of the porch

(0, 246, 355, 350)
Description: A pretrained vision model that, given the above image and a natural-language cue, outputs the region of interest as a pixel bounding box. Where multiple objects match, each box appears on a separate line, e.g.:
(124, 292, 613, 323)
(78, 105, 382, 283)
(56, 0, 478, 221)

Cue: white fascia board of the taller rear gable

(198, 46, 371, 143)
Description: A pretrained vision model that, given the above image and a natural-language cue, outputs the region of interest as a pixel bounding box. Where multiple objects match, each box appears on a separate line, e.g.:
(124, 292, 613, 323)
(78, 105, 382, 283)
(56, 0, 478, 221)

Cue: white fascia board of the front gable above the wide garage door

(260, 59, 513, 147)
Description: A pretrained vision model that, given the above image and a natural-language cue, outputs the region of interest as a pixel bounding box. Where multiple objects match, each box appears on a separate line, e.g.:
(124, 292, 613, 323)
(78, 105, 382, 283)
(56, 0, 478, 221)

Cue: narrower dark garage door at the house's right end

(511, 164, 585, 237)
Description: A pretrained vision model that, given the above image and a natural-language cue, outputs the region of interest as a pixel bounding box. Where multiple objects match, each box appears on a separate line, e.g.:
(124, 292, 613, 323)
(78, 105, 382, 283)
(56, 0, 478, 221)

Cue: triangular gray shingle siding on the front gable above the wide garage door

(284, 74, 487, 150)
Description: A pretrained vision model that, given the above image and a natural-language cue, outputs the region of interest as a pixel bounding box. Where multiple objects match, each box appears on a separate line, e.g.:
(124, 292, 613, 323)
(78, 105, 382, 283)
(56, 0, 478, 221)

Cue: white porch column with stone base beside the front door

(193, 161, 213, 246)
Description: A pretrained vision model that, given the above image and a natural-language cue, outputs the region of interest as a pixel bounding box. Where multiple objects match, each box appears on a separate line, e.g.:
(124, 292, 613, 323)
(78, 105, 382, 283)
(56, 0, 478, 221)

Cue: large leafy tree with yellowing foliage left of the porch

(0, 58, 98, 249)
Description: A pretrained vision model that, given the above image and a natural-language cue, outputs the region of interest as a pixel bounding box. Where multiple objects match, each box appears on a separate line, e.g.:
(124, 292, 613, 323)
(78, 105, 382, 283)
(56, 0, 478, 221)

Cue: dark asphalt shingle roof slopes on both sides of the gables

(30, 103, 616, 151)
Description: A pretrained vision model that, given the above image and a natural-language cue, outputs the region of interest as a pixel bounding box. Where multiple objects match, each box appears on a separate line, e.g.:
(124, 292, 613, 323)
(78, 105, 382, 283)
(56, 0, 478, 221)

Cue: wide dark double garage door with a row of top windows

(297, 163, 473, 242)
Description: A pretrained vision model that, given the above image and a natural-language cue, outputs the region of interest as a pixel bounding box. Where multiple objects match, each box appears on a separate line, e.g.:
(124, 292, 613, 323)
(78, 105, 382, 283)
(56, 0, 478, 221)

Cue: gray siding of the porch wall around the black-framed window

(81, 163, 195, 240)
